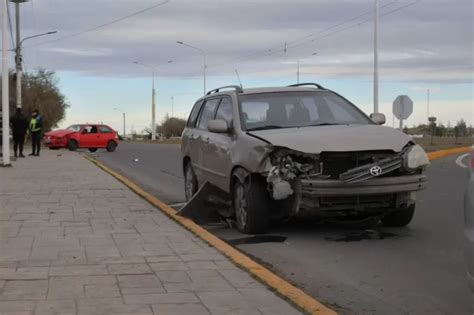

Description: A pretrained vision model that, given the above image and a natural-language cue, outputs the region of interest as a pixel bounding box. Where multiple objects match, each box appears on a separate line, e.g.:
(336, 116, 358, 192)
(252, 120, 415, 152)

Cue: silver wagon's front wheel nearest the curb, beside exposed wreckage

(232, 176, 269, 234)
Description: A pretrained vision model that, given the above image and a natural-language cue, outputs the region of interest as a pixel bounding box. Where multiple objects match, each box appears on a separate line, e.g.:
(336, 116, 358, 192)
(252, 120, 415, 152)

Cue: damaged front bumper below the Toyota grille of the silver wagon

(290, 174, 427, 215)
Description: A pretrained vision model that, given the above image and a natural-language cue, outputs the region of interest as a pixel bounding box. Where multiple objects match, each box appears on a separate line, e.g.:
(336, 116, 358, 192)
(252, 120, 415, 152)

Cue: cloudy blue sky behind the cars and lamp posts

(6, 0, 474, 132)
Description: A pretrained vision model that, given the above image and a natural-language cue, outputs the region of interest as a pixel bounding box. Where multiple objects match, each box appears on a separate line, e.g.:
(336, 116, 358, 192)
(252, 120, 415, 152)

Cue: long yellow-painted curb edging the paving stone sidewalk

(84, 155, 337, 315)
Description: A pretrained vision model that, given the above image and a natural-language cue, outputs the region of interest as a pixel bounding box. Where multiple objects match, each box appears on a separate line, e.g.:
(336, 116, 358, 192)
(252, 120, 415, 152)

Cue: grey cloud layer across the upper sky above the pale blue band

(14, 0, 473, 82)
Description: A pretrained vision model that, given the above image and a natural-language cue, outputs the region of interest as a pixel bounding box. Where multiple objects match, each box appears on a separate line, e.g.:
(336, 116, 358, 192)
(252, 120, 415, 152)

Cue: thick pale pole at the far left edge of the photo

(2, 0, 10, 166)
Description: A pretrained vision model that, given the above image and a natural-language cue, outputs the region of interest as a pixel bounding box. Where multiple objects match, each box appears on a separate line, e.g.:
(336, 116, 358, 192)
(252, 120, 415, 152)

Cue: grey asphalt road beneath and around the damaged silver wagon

(90, 143, 474, 314)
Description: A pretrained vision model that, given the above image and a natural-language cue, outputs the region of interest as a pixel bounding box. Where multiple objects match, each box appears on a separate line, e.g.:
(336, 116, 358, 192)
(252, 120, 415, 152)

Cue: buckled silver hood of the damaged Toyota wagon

(248, 125, 411, 154)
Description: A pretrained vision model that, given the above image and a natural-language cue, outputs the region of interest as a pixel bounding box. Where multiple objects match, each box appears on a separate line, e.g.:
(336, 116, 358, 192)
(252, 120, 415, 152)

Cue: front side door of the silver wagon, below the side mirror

(203, 96, 233, 189)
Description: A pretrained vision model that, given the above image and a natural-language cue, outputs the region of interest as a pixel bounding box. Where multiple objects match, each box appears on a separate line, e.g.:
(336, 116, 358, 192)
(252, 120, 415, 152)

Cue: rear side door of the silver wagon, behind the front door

(193, 97, 221, 184)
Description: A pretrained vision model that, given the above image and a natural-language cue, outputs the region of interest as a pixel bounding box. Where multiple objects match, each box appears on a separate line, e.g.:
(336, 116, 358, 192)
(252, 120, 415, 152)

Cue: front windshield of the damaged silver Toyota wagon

(240, 91, 372, 131)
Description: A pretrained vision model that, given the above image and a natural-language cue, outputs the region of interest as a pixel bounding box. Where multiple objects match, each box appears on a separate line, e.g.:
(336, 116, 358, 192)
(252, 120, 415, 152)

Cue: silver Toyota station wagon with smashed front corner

(181, 83, 429, 234)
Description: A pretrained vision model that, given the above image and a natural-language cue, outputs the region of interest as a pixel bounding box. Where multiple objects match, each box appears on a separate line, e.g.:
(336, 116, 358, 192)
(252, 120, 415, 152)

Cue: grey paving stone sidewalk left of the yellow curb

(0, 150, 300, 315)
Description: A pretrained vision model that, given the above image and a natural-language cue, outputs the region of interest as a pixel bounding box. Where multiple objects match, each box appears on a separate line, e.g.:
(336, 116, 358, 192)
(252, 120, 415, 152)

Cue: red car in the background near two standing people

(43, 124, 118, 152)
